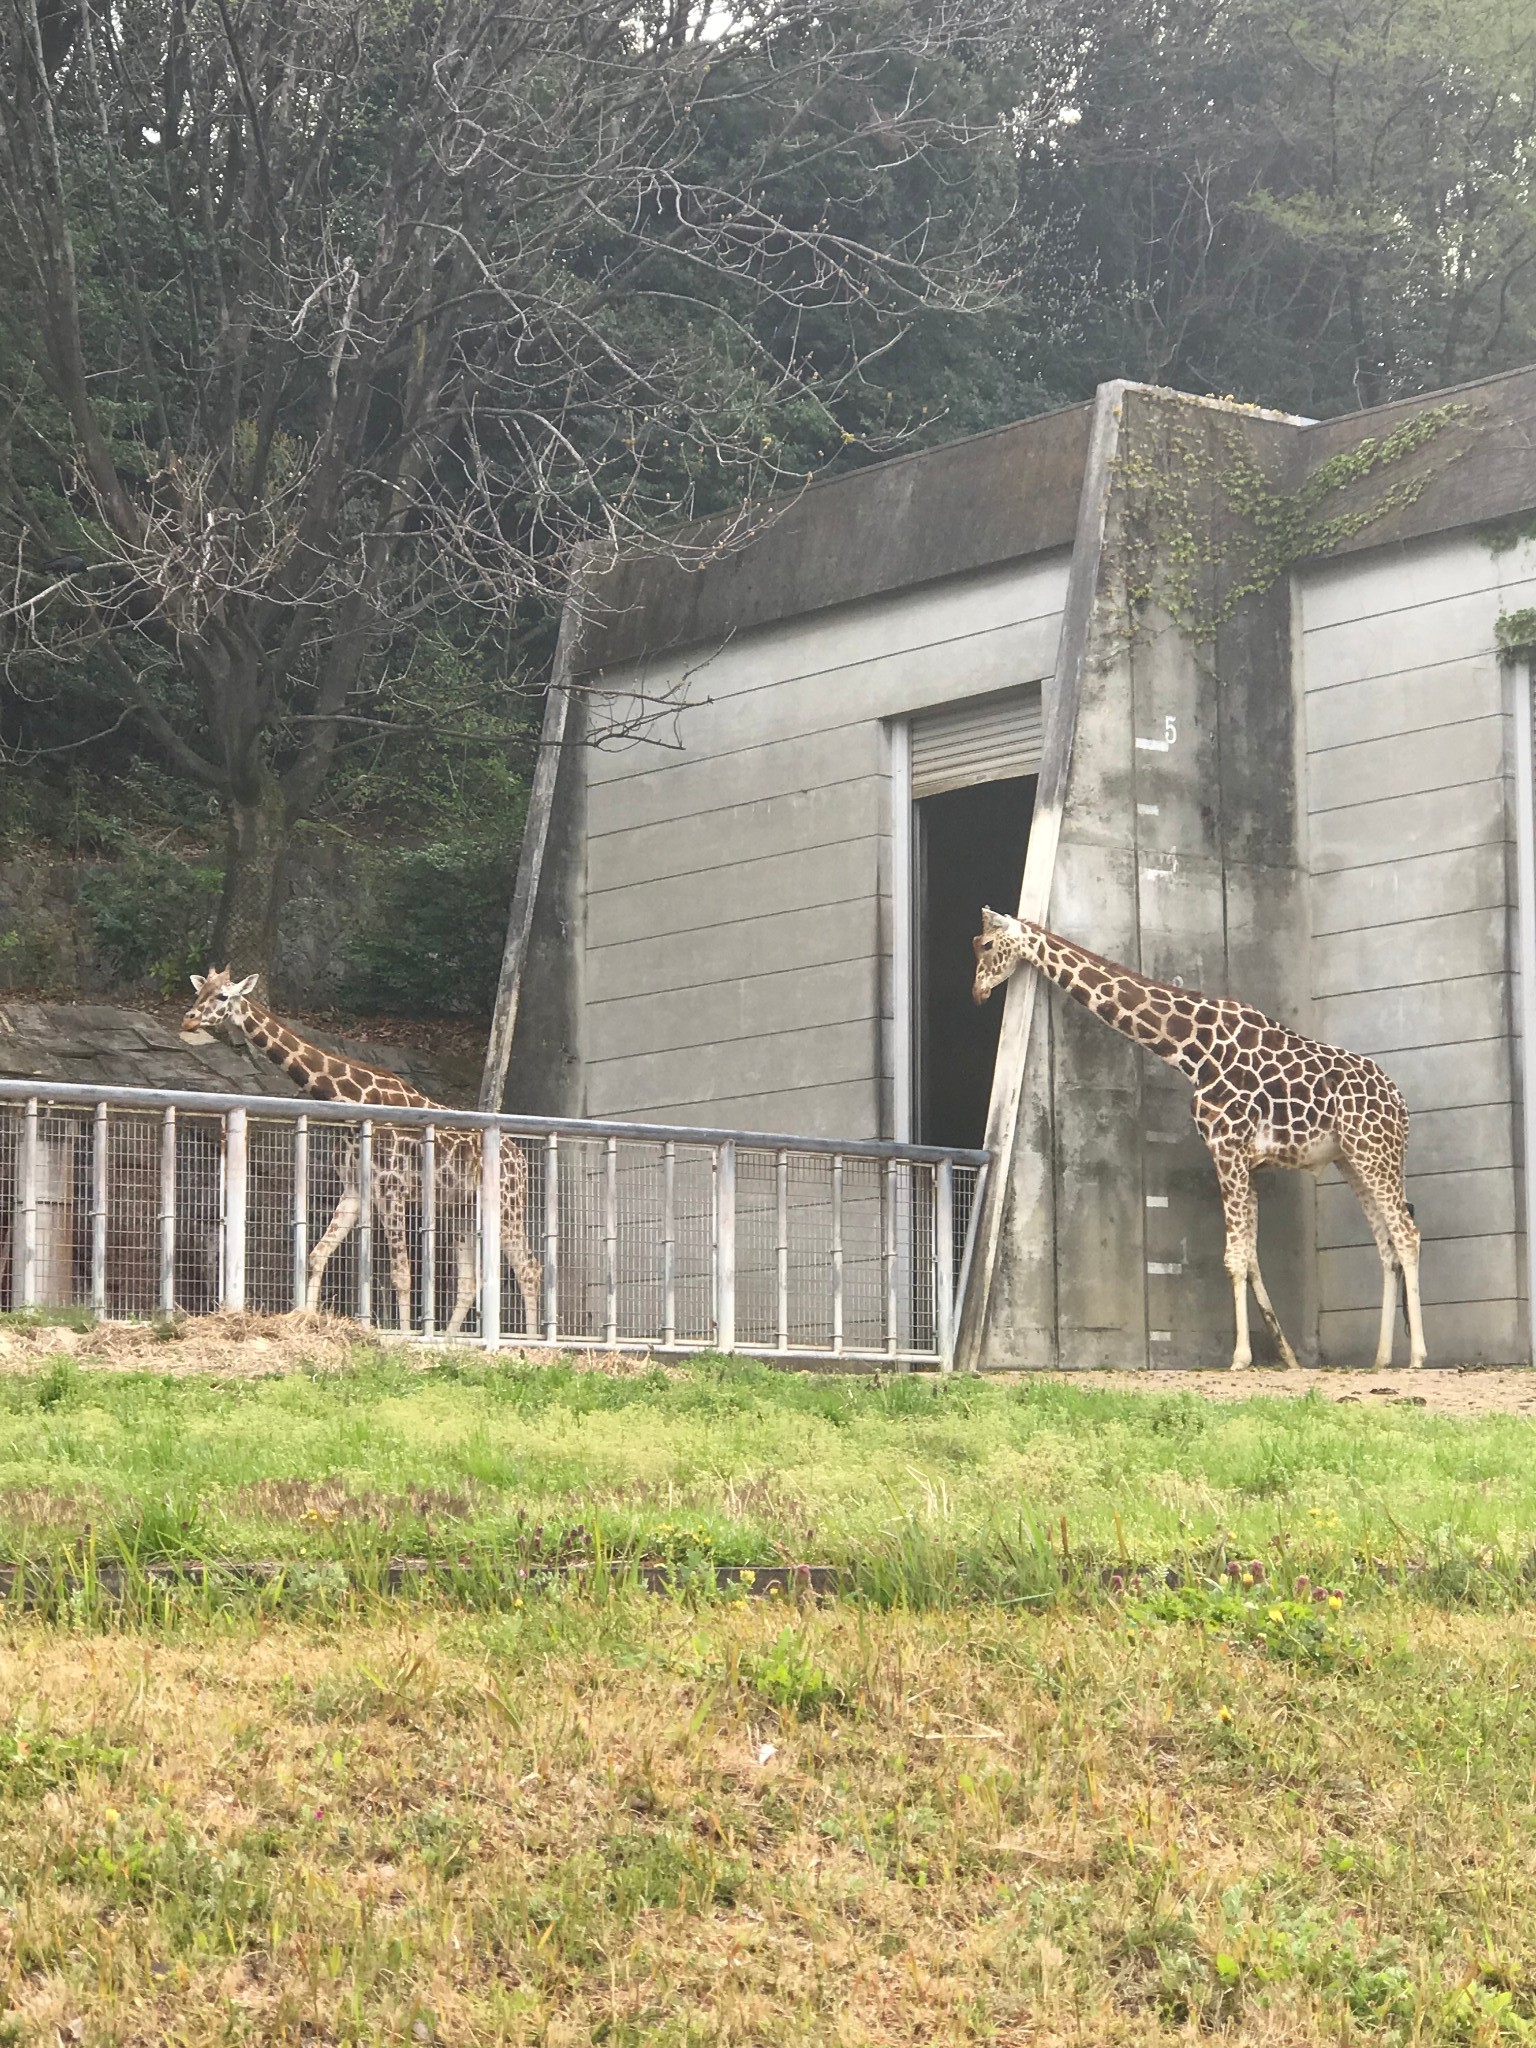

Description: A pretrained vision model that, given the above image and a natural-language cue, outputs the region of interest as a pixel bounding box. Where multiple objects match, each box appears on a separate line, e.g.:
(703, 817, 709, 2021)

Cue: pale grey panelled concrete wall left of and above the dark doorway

(555, 551, 1067, 1137)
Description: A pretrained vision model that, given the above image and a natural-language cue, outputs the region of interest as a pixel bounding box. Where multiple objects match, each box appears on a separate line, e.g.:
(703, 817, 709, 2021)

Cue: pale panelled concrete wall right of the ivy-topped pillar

(1296, 530, 1536, 1362)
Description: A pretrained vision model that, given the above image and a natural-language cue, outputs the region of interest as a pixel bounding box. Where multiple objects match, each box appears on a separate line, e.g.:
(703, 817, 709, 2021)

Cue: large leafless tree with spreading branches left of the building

(0, 0, 1012, 967)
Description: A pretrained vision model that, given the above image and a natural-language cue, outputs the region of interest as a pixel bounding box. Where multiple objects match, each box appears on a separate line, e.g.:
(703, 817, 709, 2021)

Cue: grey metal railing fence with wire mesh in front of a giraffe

(0, 1081, 985, 1368)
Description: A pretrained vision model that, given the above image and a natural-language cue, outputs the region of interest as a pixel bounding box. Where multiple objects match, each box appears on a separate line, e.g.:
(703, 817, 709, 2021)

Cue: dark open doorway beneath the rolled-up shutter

(913, 774, 1038, 1147)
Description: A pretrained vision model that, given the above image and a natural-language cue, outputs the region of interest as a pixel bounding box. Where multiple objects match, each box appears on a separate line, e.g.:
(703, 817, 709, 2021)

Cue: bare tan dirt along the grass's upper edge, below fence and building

(0, 1315, 1536, 1415)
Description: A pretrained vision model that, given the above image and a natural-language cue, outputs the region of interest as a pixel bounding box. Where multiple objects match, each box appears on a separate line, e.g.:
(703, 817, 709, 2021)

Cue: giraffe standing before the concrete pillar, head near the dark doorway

(971, 909, 1423, 1372)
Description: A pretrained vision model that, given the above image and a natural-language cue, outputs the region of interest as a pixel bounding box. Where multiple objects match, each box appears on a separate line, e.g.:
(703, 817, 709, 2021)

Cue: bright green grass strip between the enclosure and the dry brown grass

(0, 1350, 1536, 1604)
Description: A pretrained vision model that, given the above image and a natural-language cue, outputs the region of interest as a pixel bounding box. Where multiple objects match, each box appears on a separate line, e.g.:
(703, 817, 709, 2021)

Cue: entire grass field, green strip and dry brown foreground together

(0, 1354, 1536, 2048)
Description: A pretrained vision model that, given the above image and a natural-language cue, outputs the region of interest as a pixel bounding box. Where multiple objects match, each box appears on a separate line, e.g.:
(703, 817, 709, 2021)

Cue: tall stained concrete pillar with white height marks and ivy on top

(981, 389, 1315, 1370)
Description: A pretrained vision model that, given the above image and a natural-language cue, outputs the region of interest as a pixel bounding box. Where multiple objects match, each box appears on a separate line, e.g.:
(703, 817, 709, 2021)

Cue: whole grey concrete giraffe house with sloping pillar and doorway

(508, 371, 1536, 1366)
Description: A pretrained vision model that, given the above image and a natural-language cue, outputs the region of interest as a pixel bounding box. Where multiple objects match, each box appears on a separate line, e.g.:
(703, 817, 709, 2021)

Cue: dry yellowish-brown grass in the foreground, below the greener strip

(0, 1599, 1536, 2048)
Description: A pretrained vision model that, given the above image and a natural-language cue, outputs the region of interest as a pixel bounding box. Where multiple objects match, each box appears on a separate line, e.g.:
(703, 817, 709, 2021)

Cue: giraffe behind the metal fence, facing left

(182, 967, 541, 1337)
